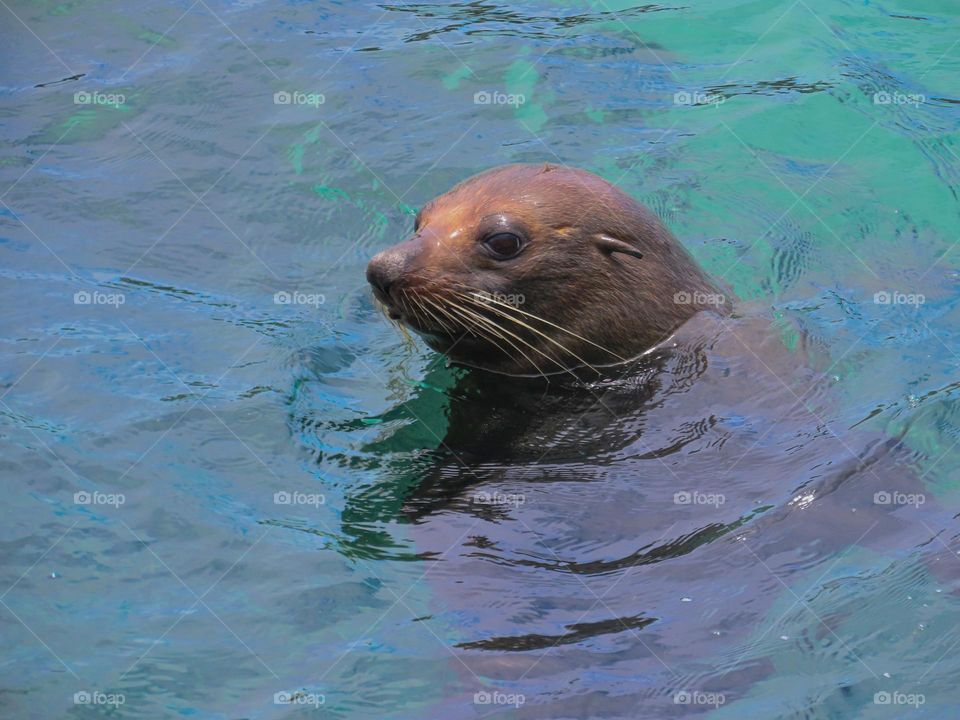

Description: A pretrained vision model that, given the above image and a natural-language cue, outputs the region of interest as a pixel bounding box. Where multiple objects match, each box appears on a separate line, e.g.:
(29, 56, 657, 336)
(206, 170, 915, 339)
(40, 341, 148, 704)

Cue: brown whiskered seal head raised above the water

(366, 164, 729, 376)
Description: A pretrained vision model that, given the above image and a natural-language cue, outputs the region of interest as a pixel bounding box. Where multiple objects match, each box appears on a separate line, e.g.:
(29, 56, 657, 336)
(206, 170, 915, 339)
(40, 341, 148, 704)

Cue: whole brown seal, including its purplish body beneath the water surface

(343, 165, 944, 717)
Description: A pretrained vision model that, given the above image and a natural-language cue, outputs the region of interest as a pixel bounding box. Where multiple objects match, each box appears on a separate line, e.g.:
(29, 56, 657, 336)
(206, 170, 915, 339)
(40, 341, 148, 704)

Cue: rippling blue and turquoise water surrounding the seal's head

(0, 0, 960, 718)
